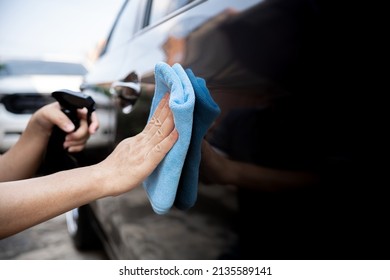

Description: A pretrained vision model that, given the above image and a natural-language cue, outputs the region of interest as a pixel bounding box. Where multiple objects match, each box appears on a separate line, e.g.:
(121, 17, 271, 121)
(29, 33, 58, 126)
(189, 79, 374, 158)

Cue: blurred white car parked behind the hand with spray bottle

(0, 59, 115, 153)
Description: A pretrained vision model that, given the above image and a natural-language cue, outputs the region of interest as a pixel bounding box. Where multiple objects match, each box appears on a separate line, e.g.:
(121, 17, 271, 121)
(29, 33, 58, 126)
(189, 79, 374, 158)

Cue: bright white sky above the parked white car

(0, 0, 124, 63)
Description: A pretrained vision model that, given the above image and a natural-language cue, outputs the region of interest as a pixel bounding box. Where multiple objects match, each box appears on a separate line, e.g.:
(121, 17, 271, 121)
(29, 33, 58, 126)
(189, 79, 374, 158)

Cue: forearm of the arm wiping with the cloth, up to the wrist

(0, 166, 106, 238)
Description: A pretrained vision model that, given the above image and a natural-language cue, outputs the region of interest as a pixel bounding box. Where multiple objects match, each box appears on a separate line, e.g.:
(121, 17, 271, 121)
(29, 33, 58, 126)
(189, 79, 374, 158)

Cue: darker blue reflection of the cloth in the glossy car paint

(174, 69, 221, 210)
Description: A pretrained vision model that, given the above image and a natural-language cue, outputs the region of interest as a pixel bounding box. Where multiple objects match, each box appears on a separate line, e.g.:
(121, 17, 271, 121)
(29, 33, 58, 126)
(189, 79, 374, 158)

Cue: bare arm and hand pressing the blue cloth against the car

(0, 94, 178, 238)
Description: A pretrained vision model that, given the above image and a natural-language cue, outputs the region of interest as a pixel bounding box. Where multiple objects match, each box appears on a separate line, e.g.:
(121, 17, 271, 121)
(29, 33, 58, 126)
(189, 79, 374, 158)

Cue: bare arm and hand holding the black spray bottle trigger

(0, 102, 99, 182)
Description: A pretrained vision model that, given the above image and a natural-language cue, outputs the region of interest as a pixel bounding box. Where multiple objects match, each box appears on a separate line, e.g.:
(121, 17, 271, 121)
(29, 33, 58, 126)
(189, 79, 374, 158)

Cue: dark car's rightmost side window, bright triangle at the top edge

(149, 0, 193, 25)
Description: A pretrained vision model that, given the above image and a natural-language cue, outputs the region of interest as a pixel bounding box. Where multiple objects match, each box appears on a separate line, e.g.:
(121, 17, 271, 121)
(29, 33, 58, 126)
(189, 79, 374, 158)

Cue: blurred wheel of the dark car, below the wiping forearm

(66, 205, 102, 250)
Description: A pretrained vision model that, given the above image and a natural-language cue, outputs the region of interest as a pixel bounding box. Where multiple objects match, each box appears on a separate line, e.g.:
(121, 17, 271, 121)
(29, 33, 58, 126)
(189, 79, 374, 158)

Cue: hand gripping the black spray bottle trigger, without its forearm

(30, 102, 99, 152)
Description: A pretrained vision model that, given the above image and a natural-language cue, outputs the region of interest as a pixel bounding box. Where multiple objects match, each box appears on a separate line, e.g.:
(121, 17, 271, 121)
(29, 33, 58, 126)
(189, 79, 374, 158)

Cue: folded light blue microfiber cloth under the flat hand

(143, 62, 195, 214)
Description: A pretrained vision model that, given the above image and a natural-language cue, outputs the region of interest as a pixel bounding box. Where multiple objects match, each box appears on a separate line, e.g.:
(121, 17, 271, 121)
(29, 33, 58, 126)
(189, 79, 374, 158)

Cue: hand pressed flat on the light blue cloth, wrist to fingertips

(96, 94, 179, 195)
